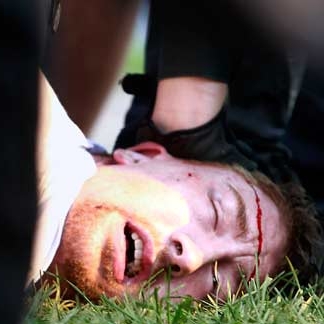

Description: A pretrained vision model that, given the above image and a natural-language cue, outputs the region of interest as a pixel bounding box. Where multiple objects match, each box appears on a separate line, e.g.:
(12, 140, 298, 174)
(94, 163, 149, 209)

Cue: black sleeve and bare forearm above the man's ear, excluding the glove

(152, 0, 235, 133)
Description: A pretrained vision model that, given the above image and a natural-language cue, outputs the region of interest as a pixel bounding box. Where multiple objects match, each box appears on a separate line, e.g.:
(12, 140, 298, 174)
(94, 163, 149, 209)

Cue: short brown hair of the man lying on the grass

(234, 166, 323, 284)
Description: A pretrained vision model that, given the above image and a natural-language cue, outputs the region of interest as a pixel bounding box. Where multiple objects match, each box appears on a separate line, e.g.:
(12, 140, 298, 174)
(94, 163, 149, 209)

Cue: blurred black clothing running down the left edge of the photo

(0, 0, 52, 324)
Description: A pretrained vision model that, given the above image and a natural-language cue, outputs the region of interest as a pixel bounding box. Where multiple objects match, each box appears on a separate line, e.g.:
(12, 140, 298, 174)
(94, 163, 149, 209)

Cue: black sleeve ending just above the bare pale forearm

(146, 0, 235, 82)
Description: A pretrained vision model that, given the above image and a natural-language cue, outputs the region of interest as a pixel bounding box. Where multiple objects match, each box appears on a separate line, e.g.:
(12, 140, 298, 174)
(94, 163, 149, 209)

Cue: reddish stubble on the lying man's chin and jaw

(49, 200, 139, 300)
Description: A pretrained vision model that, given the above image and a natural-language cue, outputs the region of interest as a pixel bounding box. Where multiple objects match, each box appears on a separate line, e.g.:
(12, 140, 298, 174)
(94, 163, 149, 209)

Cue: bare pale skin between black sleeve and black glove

(152, 77, 227, 133)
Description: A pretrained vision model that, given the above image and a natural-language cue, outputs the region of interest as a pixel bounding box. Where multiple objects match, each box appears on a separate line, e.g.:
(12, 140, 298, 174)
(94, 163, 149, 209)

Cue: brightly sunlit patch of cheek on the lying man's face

(92, 169, 190, 231)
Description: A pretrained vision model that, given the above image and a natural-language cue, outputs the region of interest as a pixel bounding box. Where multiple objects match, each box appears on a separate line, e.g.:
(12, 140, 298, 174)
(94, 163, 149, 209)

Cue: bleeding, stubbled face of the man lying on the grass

(51, 143, 286, 298)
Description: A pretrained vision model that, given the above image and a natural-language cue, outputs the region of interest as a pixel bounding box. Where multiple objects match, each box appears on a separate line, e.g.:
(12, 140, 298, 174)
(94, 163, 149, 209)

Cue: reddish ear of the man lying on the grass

(113, 142, 168, 164)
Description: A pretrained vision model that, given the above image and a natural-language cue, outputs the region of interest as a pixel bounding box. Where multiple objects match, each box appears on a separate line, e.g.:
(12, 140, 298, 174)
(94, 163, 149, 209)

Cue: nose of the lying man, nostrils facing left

(168, 233, 204, 277)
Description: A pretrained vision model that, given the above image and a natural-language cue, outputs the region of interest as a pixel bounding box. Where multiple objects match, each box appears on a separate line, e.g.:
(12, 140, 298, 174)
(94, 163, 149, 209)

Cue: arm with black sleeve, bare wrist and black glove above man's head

(123, 0, 255, 169)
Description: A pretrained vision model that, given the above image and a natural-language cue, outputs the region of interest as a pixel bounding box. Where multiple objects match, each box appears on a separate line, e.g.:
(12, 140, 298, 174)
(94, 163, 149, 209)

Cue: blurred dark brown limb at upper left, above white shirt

(43, 0, 139, 132)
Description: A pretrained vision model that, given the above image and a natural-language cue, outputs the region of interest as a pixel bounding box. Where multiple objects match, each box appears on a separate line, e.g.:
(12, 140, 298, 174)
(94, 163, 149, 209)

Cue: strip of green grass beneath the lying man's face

(23, 273, 324, 324)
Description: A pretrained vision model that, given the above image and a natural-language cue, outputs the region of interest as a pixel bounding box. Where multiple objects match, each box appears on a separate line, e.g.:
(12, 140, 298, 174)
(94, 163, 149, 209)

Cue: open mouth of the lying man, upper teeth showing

(124, 224, 143, 278)
